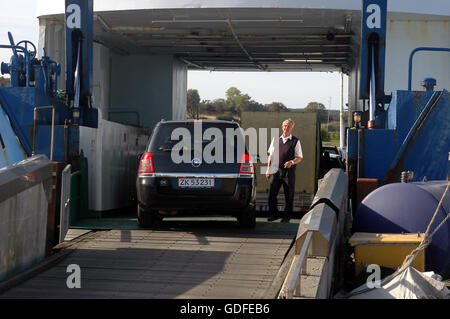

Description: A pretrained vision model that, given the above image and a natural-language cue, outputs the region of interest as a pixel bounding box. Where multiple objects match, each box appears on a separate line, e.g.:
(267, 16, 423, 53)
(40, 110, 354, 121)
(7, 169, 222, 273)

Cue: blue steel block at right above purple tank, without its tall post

(347, 90, 450, 184)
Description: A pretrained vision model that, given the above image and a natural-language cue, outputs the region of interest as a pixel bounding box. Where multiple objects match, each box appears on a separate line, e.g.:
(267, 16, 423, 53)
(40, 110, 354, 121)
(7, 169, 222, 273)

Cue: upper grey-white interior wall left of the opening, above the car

(109, 54, 187, 128)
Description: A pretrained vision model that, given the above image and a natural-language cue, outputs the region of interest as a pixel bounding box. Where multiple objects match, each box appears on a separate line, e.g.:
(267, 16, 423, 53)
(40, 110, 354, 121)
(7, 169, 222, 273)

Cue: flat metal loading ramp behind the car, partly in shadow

(0, 228, 297, 299)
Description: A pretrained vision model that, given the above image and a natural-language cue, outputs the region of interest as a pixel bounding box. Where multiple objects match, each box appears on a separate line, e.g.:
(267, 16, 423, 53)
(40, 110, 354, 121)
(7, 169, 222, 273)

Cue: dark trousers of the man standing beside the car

(269, 169, 295, 218)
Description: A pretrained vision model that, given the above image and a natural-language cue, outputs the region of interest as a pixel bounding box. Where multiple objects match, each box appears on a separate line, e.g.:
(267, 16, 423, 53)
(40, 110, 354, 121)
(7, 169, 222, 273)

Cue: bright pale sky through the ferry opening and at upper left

(0, 0, 347, 109)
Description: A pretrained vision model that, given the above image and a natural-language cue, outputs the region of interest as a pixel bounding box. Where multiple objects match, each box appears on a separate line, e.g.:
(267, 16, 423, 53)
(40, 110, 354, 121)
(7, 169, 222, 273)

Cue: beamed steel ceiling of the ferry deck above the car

(47, 8, 361, 72)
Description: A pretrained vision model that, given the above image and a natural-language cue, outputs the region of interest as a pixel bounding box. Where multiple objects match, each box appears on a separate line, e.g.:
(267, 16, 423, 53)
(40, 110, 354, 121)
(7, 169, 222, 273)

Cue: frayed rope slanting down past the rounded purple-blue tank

(348, 181, 450, 297)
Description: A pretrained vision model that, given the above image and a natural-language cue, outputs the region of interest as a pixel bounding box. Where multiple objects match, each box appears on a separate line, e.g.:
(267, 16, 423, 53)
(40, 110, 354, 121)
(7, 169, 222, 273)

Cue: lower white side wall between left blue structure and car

(80, 120, 148, 211)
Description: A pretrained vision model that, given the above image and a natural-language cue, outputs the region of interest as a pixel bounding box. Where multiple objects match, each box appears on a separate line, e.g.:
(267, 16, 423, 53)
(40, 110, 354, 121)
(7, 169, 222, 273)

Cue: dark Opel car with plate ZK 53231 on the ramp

(136, 120, 256, 227)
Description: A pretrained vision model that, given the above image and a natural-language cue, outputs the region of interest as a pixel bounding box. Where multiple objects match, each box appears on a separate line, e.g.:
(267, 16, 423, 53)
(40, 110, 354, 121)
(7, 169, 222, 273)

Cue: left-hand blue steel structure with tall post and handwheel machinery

(0, 0, 98, 169)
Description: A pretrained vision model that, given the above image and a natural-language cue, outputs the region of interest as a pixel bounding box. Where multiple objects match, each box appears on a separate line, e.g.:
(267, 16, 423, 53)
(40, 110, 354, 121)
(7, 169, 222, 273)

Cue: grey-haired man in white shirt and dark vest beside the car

(266, 119, 303, 222)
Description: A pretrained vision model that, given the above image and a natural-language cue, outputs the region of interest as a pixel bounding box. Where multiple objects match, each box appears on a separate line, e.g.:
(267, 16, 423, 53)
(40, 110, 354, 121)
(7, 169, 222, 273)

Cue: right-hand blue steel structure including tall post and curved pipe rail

(347, 0, 450, 184)
